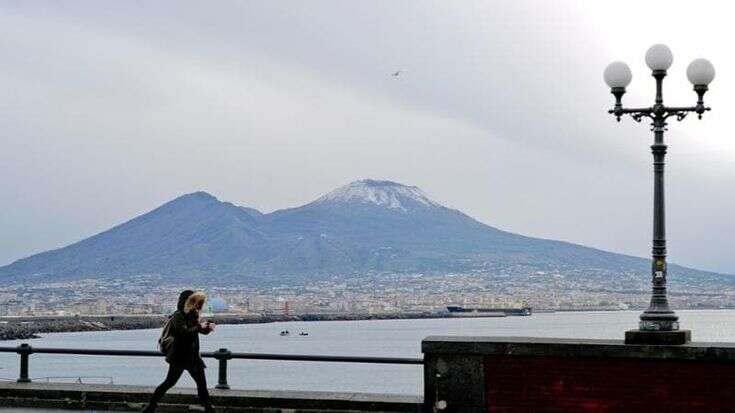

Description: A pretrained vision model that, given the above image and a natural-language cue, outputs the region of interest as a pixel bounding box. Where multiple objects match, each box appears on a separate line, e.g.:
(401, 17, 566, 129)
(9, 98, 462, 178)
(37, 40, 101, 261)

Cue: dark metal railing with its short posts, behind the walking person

(0, 343, 424, 390)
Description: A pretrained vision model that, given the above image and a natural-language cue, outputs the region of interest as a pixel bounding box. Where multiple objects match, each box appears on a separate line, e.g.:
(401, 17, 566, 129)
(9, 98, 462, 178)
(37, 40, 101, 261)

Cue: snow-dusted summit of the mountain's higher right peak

(314, 179, 440, 212)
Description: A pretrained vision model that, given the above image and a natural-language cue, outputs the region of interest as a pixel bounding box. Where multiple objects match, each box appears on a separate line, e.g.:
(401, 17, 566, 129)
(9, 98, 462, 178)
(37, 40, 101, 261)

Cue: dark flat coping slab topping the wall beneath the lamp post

(421, 336, 735, 363)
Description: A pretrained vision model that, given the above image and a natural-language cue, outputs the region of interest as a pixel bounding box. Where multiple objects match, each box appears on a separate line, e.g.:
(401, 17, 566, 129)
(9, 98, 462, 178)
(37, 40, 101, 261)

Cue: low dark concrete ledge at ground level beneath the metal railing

(0, 382, 422, 413)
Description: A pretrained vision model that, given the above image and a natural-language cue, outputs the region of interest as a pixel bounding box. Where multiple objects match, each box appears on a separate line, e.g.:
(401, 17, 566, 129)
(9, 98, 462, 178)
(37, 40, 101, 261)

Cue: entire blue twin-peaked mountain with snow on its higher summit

(0, 180, 729, 281)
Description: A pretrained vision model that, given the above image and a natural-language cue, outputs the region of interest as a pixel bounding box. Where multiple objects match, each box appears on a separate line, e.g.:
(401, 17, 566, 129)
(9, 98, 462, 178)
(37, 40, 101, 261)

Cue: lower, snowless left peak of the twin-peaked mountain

(0, 192, 264, 278)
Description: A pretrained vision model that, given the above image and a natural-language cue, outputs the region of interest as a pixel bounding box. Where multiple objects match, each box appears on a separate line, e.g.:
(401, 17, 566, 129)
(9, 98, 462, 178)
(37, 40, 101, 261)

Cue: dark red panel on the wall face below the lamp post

(485, 356, 735, 413)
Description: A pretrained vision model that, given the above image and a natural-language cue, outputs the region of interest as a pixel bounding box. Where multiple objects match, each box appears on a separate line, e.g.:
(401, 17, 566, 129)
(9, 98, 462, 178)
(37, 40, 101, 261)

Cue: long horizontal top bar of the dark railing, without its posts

(0, 347, 424, 365)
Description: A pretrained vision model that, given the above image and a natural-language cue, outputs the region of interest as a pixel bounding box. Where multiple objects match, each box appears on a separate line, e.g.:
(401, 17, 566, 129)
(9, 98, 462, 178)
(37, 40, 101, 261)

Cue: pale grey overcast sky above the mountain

(0, 0, 735, 273)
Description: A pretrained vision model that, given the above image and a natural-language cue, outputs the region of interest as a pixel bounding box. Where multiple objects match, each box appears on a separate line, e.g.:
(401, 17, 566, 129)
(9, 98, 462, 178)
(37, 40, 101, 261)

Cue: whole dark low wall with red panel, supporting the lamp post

(423, 337, 735, 413)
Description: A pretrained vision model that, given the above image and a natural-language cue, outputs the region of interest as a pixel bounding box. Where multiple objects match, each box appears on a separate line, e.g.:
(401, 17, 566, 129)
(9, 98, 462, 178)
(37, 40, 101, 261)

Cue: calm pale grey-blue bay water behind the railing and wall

(0, 310, 735, 395)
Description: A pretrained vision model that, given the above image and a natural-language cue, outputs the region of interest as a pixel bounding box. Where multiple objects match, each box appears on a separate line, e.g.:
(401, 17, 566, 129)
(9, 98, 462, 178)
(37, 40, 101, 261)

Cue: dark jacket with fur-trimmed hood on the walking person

(166, 290, 210, 370)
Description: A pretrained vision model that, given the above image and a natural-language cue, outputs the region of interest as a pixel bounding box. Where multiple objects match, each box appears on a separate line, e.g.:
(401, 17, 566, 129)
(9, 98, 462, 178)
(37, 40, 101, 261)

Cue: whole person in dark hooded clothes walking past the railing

(143, 290, 215, 413)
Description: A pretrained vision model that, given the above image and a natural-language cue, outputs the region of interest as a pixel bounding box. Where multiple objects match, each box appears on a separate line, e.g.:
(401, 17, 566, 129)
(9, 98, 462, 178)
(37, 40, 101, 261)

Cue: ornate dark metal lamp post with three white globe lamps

(604, 44, 715, 344)
